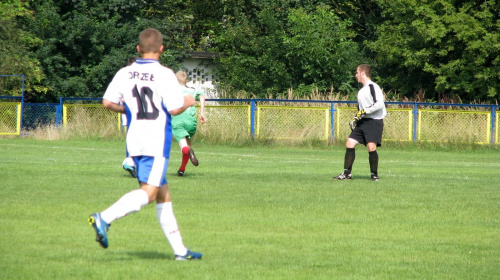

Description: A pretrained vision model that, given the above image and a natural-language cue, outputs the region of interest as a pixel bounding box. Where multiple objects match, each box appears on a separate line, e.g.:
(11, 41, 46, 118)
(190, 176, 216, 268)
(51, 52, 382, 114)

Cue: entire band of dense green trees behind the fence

(0, 0, 500, 102)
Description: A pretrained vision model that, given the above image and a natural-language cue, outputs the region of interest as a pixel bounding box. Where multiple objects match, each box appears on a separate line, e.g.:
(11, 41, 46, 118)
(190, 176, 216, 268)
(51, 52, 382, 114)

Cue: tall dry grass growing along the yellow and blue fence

(9, 103, 498, 149)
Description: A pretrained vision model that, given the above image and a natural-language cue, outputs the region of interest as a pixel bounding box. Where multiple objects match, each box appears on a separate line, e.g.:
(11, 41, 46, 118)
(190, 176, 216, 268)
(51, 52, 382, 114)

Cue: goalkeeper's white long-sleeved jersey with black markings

(358, 81, 387, 119)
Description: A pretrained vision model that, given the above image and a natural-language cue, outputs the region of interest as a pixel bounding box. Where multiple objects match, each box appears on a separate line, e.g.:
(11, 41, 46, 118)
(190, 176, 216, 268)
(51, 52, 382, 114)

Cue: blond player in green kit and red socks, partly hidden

(172, 71, 206, 176)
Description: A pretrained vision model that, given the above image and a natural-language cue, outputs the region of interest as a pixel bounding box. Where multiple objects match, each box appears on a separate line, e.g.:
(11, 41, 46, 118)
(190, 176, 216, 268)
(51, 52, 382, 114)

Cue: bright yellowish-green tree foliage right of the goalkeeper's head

(366, 0, 500, 102)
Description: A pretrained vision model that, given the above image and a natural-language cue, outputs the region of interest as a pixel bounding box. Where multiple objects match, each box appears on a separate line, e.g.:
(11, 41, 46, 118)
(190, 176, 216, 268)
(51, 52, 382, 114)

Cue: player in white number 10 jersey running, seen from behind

(88, 28, 202, 260)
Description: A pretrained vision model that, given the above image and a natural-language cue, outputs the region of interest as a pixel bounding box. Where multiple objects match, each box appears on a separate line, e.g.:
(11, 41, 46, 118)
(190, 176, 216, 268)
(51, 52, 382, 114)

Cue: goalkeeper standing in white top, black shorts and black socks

(333, 64, 387, 181)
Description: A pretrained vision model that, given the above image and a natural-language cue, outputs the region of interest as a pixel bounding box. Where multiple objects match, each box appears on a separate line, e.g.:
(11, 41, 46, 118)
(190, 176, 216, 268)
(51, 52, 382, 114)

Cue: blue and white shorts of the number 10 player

(132, 156, 168, 187)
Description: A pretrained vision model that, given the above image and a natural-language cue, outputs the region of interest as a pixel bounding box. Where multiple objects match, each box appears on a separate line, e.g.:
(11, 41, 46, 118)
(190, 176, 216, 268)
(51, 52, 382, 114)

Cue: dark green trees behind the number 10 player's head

(22, 0, 205, 101)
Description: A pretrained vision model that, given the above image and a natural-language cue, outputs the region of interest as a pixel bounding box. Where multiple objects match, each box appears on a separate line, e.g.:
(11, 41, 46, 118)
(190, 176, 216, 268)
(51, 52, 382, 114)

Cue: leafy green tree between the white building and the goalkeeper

(216, 0, 363, 97)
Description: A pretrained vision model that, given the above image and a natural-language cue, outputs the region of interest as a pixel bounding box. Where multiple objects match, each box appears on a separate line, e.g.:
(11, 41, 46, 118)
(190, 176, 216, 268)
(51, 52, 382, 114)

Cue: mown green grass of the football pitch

(0, 139, 500, 279)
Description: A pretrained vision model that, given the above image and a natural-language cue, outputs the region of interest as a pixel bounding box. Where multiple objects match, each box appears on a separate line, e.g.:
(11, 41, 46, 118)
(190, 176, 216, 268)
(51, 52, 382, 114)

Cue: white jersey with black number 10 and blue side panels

(103, 59, 184, 158)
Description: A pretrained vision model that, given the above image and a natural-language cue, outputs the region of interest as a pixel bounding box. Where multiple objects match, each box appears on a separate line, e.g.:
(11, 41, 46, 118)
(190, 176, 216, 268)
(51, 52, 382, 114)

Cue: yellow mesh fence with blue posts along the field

(0, 98, 500, 144)
